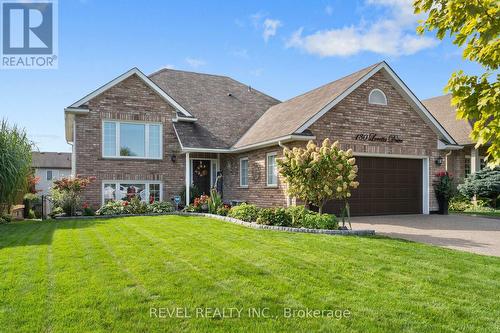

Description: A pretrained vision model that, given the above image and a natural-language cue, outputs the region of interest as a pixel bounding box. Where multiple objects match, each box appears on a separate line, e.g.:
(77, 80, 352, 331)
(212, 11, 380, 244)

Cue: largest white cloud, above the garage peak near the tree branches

(286, 0, 438, 57)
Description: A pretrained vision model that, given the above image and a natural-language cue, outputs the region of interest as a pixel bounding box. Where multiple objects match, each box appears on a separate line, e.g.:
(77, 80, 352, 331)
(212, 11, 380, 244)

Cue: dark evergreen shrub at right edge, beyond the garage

(457, 168, 500, 208)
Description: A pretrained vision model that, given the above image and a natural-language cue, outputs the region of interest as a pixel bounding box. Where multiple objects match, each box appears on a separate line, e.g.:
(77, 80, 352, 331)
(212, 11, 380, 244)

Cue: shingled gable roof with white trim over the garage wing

(234, 62, 454, 148)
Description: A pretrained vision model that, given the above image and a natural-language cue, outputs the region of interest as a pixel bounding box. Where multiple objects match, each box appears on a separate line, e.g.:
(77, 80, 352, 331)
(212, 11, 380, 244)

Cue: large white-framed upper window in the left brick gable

(103, 121, 162, 159)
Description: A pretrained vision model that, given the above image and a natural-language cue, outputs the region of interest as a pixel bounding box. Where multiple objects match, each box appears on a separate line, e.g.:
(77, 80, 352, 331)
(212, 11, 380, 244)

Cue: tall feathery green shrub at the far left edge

(0, 120, 33, 214)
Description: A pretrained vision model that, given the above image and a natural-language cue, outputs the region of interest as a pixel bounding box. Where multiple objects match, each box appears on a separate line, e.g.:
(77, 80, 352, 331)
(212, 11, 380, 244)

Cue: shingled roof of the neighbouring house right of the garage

(422, 94, 474, 145)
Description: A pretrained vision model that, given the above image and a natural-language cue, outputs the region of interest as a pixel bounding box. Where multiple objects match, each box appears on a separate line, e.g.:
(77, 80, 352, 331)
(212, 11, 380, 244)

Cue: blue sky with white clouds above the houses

(0, 0, 480, 151)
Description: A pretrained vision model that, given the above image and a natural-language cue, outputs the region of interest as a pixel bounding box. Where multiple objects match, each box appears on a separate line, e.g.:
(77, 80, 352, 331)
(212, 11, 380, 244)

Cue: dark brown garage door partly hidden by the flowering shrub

(325, 157, 422, 216)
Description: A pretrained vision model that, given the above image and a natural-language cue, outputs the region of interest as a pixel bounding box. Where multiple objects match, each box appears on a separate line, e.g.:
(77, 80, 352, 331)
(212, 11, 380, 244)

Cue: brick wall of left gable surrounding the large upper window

(75, 75, 185, 207)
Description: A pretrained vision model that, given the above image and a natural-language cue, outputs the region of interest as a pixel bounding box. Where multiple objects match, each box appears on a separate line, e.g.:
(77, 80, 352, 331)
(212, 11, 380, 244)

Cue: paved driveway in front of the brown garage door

(351, 215, 500, 257)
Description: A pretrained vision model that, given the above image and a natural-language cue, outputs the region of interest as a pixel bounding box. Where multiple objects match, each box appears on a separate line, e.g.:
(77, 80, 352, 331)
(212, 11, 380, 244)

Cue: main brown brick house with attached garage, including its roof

(65, 62, 456, 215)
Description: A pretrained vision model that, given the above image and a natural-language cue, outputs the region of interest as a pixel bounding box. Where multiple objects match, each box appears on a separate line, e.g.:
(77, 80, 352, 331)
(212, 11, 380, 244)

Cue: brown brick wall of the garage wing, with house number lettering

(221, 72, 444, 211)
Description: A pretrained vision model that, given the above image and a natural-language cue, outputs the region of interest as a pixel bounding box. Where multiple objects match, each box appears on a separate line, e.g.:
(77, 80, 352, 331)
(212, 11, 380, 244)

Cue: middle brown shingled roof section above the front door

(149, 69, 280, 149)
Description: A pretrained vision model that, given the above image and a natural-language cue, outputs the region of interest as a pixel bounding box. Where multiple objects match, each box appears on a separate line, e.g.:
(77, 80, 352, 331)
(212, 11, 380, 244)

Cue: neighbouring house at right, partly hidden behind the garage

(422, 94, 487, 179)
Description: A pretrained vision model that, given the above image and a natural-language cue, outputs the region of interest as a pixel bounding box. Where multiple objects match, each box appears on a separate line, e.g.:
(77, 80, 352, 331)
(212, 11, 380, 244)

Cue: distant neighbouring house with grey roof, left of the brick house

(31, 152, 71, 194)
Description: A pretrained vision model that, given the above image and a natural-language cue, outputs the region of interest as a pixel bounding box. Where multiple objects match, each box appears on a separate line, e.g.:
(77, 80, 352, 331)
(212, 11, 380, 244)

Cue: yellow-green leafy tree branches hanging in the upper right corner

(413, 0, 500, 167)
